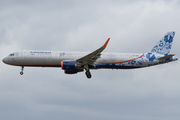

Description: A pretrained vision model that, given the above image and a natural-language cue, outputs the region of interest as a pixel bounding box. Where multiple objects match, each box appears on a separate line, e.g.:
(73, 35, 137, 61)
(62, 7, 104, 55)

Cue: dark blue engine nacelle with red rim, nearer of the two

(61, 61, 81, 70)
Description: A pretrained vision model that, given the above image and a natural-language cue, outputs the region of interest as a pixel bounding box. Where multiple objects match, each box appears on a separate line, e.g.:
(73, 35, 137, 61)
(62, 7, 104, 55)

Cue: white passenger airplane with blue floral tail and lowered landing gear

(2, 31, 178, 78)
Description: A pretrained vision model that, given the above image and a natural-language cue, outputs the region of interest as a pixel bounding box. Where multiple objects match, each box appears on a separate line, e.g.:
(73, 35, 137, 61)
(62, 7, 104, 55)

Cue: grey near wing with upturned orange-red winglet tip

(76, 38, 110, 65)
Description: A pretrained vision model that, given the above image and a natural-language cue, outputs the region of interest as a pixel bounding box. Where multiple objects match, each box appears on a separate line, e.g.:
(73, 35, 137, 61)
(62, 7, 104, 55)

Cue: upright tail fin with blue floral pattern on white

(151, 32, 175, 56)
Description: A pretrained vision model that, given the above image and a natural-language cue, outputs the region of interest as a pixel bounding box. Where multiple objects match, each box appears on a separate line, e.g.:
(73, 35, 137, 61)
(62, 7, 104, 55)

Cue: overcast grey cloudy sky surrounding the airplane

(0, 0, 180, 120)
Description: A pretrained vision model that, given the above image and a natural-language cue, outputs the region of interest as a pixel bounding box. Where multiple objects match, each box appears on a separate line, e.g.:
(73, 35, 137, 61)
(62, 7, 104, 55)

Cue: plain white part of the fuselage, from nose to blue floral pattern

(3, 51, 146, 67)
